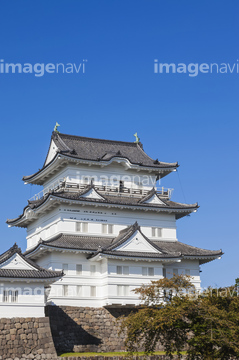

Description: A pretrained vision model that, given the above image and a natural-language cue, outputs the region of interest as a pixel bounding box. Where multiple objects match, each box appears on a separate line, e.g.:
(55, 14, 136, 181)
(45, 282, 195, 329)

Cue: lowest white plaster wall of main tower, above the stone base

(32, 251, 200, 307)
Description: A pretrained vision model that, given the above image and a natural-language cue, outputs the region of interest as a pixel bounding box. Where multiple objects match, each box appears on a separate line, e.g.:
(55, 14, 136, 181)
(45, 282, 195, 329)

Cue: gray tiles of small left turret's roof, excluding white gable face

(0, 243, 64, 279)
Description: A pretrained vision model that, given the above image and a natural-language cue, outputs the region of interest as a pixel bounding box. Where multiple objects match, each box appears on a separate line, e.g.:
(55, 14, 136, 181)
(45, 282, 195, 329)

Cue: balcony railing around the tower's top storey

(30, 179, 173, 201)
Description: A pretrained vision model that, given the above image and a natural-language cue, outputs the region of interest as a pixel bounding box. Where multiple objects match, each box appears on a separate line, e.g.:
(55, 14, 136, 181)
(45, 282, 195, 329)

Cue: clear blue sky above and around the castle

(0, 0, 239, 286)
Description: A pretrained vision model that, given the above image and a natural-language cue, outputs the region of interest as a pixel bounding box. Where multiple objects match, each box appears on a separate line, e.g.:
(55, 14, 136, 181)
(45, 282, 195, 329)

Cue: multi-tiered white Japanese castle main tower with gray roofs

(5, 130, 222, 307)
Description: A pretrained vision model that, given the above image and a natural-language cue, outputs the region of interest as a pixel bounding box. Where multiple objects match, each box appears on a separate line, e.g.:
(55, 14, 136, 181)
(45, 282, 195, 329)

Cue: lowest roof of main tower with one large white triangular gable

(25, 222, 223, 264)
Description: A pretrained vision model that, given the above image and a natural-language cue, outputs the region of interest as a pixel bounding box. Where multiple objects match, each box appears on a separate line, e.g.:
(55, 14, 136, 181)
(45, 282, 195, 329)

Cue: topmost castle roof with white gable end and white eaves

(23, 131, 178, 184)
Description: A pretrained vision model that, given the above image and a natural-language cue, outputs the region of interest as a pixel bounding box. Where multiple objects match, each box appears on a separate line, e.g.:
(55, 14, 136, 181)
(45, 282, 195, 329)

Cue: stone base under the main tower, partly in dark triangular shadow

(47, 306, 143, 353)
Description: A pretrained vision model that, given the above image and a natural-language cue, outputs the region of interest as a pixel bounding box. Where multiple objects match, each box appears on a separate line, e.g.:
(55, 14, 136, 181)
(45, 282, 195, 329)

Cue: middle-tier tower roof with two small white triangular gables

(7, 185, 199, 227)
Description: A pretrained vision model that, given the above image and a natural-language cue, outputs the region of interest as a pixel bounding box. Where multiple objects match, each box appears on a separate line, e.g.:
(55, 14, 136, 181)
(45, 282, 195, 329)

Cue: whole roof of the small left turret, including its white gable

(0, 244, 64, 281)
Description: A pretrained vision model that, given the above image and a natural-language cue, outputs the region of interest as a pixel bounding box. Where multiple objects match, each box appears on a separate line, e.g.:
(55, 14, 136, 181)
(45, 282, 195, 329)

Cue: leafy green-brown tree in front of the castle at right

(121, 275, 239, 360)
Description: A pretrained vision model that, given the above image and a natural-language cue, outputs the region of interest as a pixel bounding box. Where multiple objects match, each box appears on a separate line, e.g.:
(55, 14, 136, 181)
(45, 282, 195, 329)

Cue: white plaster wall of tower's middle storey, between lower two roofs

(27, 204, 177, 249)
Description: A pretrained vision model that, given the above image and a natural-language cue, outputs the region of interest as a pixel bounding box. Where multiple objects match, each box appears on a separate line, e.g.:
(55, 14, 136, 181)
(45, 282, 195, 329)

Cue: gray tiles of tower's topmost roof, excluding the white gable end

(23, 131, 178, 181)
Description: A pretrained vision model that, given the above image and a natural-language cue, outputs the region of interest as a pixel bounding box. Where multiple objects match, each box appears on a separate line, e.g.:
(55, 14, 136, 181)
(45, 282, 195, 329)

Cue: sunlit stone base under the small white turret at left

(0, 318, 57, 360)
